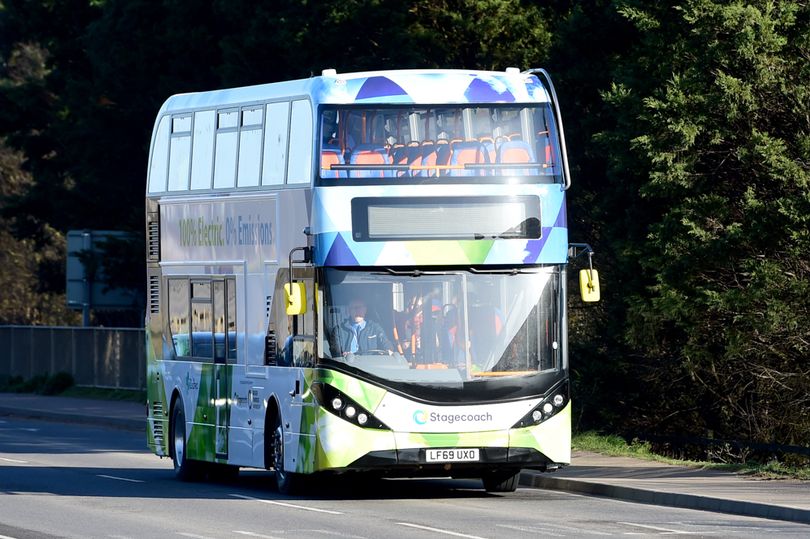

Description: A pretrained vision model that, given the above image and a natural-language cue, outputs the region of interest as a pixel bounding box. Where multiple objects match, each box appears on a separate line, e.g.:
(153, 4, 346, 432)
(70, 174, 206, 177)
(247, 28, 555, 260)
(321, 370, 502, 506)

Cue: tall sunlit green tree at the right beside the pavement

(602, 0, 810, 444)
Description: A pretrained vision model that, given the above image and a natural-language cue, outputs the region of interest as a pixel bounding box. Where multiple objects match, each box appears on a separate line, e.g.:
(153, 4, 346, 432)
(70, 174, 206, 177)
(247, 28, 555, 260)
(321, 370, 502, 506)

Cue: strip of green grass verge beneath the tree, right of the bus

(571, 432, 810, 481)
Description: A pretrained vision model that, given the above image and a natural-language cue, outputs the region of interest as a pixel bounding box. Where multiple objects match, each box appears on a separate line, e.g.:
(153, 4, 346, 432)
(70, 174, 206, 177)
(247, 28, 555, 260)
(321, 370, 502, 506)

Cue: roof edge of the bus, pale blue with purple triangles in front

(159, 68, 549, 116)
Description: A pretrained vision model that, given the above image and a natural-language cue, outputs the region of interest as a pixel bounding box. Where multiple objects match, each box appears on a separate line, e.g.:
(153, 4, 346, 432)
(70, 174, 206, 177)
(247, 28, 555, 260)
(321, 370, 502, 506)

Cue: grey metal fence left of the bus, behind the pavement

(0, 326, 146, 389)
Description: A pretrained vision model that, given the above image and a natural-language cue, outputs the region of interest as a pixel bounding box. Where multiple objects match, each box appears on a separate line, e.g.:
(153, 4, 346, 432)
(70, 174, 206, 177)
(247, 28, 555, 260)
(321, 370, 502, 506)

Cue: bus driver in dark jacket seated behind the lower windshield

(329, 299, 394, 357)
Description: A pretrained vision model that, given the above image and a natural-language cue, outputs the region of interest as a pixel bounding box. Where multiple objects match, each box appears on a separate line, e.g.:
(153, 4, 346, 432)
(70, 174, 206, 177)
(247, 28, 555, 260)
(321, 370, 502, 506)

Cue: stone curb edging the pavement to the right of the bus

(520, 471, 810, 524)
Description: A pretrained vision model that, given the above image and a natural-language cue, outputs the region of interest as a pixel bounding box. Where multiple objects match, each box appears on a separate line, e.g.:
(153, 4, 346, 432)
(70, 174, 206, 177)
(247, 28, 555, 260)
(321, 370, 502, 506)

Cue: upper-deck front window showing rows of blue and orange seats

(319, 104, 562, 185)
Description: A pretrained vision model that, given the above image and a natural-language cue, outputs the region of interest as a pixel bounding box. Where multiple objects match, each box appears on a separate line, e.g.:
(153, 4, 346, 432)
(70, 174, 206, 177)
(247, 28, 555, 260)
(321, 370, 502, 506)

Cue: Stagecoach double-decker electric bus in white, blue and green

(146, 68, 598, 492)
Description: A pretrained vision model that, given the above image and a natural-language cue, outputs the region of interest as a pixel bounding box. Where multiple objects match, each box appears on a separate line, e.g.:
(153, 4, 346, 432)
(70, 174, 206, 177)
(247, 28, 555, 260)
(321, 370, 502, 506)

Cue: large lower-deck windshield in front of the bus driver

(319, 267, 562, 387)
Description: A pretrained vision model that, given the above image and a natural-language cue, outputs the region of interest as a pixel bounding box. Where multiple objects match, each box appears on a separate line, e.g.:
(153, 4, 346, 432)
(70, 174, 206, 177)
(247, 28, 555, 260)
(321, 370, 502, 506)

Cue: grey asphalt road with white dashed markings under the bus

(0, 418, 810, 539)
